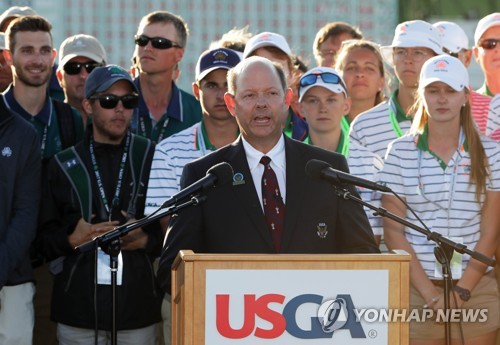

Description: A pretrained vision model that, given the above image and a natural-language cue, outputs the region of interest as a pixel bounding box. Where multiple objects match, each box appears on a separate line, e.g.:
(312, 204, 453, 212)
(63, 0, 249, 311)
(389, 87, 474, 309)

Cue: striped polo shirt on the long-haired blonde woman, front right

(379, 127, 500, 278)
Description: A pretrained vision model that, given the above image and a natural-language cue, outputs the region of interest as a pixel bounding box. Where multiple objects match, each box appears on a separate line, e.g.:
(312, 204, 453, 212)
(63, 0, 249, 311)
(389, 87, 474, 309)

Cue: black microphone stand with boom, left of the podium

(75, 195, 207, 345)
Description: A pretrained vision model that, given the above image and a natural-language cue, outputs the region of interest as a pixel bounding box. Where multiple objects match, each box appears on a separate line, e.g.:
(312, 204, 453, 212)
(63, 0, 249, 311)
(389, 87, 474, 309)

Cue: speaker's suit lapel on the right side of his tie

(281, 136, 307, 252)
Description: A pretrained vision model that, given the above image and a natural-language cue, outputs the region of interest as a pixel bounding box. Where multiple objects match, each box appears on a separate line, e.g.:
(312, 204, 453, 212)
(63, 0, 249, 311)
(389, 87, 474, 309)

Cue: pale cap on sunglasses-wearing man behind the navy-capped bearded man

(59, 34, 106, 68)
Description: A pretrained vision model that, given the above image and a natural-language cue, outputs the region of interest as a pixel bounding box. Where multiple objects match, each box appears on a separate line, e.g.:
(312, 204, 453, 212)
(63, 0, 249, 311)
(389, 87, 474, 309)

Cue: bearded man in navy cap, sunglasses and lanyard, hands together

(40, 65, 163, 345)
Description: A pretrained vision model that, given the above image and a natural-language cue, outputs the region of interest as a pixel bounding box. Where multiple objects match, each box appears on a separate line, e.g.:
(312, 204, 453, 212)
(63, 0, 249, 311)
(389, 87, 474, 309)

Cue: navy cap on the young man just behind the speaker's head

(196, 48, 241, 81)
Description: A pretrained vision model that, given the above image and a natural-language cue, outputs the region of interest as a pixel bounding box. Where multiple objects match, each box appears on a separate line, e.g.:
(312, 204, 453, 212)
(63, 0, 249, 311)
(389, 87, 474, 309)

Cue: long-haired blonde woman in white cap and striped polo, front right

(379, 55, 500, 345)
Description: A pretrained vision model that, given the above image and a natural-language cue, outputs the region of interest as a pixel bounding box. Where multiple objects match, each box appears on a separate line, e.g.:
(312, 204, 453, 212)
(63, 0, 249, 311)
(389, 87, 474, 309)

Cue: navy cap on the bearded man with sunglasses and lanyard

(85, 65, 139, 99)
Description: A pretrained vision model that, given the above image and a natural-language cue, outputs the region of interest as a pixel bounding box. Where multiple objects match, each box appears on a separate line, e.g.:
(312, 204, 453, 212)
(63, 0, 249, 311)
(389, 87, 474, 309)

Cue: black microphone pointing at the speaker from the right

(306, 159, 392, 193)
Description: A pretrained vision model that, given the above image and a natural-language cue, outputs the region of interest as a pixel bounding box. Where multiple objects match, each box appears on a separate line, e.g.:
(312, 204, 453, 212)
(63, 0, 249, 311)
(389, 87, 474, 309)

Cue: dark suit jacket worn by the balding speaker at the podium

(158, 136, 379, 292)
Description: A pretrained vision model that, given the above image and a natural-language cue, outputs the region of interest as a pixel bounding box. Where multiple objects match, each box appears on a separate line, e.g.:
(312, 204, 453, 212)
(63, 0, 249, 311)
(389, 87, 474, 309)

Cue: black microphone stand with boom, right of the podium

(332, 183, 496, 345)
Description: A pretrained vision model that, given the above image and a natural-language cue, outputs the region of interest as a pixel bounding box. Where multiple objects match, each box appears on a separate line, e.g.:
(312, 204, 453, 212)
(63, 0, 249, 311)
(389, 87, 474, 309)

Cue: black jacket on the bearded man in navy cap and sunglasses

(39, 128, 163, 330)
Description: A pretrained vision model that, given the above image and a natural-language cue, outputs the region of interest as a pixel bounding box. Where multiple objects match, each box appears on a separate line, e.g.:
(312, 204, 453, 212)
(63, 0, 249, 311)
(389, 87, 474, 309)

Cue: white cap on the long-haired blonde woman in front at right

(418, 54, 469, 91)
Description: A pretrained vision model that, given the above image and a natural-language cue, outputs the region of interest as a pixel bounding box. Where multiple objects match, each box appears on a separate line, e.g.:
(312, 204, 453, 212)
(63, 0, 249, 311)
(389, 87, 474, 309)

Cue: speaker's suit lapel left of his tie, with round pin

(224, 138, 274, 249)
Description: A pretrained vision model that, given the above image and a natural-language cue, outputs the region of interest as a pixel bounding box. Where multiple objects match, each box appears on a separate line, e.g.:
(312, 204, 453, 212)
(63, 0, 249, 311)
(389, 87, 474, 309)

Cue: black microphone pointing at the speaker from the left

(160, 162, 233, 209)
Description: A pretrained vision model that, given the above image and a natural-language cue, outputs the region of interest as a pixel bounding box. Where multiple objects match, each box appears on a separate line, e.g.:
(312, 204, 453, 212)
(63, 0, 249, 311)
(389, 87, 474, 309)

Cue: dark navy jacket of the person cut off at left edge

(0, 97, 41, 290)
